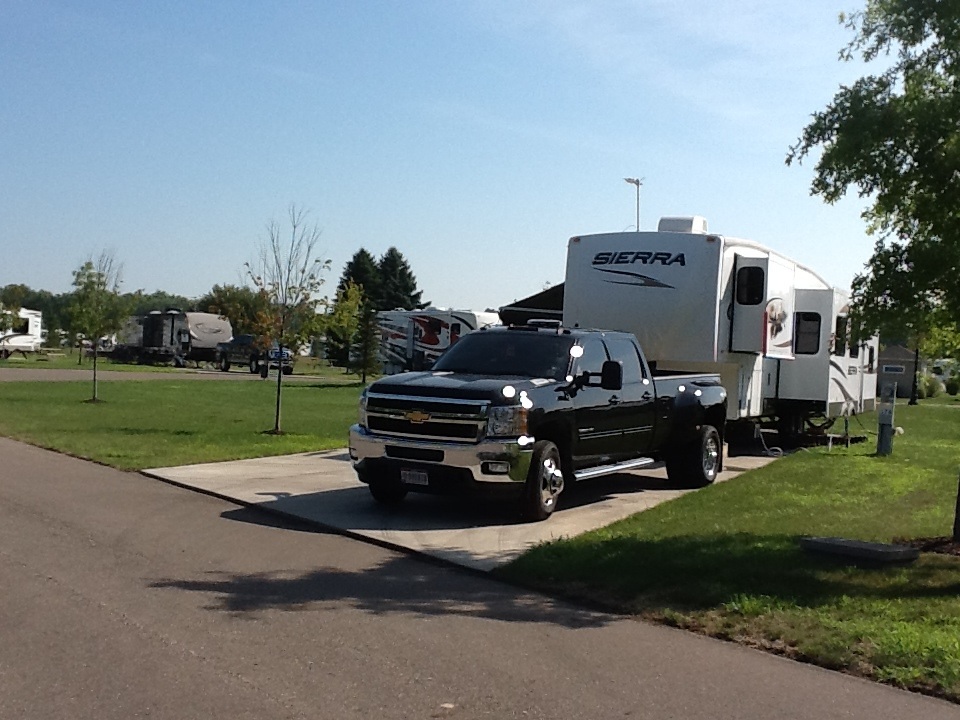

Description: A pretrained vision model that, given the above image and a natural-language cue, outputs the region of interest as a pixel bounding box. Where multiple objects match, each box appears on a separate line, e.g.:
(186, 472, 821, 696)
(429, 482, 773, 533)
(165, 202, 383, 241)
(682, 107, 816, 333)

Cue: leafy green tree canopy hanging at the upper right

(787, 0, 960, 336)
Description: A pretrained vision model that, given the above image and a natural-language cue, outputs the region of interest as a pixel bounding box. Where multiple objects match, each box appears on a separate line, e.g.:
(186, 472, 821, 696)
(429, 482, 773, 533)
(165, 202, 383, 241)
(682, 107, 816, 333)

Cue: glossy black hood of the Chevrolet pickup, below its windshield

(369, 371, 557, 403)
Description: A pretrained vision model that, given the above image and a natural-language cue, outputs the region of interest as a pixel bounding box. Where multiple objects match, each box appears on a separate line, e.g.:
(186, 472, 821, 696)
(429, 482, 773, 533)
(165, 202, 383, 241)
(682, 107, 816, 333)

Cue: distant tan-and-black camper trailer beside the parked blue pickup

(114, 310, 233, 365)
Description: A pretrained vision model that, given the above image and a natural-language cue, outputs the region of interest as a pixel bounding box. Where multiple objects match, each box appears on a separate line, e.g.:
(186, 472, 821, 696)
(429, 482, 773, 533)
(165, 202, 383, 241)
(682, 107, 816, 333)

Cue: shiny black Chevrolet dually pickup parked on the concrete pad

(350, 326, 727, 520)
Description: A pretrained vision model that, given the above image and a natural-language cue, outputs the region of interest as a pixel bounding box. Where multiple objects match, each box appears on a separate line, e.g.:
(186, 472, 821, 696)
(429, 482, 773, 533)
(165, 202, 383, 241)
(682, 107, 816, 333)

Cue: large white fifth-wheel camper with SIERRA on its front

(563, 217, 877, 433)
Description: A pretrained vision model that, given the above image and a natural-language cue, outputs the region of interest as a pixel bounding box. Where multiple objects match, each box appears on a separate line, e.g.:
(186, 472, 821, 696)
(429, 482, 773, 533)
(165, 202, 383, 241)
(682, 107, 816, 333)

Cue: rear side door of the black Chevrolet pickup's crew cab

(604, 335, 656, 457)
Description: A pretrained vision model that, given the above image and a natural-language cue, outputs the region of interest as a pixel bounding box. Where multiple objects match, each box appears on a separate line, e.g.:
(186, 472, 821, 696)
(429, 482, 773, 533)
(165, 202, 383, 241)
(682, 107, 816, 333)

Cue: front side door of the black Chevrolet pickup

(573, 337, 622, 466)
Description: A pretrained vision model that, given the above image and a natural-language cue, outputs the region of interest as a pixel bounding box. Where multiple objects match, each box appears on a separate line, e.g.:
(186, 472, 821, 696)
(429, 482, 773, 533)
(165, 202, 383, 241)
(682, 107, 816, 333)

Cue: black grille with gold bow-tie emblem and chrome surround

(367, 394, 488, 442)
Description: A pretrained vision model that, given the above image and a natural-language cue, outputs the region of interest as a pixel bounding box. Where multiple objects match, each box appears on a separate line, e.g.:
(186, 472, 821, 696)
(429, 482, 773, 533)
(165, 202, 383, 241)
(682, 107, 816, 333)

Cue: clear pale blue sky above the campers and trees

(0, 0, 873, 309)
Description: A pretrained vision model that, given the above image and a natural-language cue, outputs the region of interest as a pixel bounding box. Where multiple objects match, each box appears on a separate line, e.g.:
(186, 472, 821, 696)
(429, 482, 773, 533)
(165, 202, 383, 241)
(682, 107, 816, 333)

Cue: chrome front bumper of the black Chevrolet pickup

(350, 425, 533, 484)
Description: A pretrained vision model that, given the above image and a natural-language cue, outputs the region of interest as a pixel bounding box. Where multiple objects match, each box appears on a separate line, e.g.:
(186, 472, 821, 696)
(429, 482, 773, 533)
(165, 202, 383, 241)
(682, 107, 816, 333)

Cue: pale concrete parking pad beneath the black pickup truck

(143, 450, 774, 571)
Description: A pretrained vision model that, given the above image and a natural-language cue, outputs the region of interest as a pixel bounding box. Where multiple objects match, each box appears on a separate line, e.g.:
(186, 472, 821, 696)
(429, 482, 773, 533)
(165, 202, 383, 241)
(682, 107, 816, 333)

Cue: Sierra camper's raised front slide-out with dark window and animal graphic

(730, 254, 795, 360)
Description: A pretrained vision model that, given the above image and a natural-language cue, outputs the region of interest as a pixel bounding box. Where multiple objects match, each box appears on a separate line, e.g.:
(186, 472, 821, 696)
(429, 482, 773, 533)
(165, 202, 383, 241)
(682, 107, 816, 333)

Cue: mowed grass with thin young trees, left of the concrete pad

(0, 376, 360, 470)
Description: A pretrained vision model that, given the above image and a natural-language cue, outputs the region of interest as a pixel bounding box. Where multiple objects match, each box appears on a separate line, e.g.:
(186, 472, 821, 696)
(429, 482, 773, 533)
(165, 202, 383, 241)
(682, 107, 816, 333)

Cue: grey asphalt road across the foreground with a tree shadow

(0, 439, 960, 720)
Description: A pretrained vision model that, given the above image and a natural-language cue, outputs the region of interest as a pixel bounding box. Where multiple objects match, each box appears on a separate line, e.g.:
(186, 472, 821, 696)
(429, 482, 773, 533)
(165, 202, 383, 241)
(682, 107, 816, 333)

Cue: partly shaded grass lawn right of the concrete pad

(502, 396, 960, 700)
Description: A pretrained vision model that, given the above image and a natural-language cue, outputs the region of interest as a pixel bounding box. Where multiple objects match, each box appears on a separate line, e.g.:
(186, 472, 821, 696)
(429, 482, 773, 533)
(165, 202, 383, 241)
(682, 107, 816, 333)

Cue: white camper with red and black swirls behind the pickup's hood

(377, 308, 500, 375)
